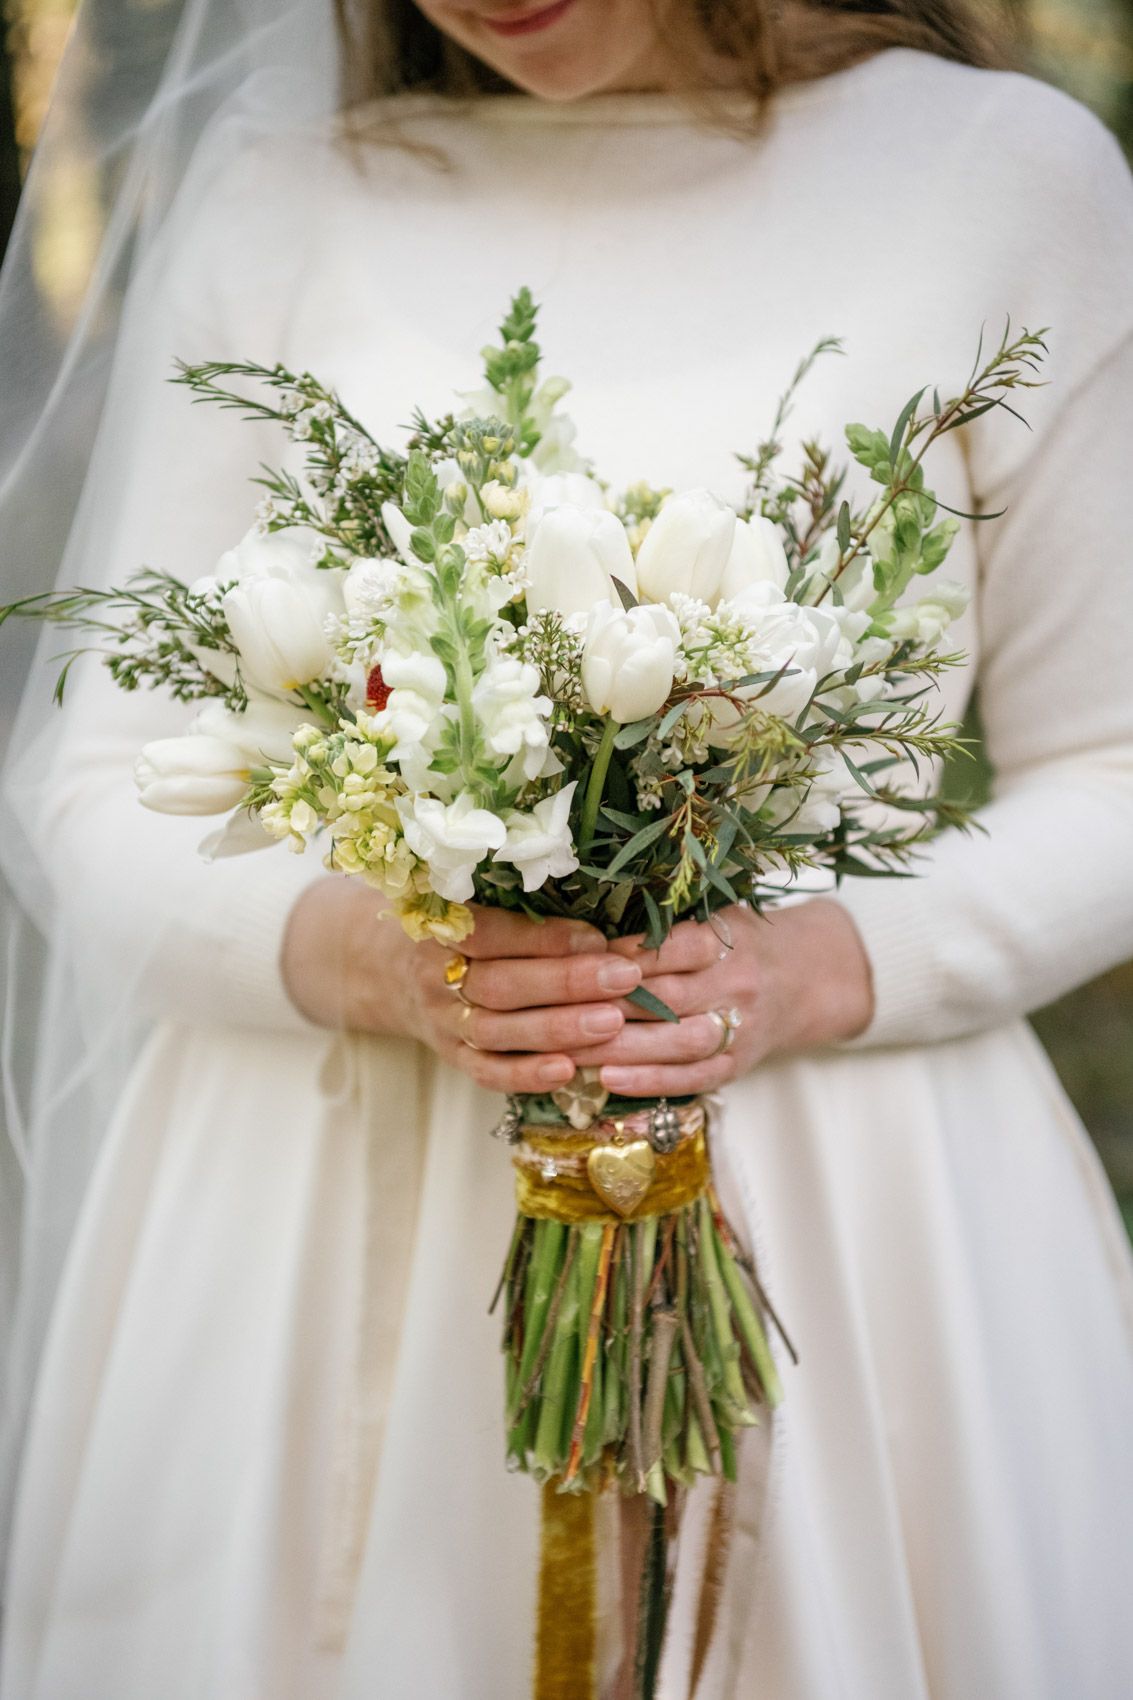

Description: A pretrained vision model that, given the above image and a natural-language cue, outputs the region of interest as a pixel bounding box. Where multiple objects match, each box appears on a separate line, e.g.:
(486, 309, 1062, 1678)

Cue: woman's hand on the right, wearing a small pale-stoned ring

(573, 898, 873, 1098)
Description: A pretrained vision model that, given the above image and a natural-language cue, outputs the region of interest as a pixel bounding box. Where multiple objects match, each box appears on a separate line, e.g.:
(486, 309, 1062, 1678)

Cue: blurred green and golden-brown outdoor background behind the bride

(0, 0, 1133, 1233)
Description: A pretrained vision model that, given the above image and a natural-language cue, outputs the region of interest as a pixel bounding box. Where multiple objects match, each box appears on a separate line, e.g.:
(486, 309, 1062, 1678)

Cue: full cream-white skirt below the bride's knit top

(0, 1023, 1133, 1700)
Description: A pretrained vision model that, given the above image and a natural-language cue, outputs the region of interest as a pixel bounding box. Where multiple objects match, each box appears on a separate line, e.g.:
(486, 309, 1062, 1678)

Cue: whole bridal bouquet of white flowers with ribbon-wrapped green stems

(0, 291, 1043, 1695)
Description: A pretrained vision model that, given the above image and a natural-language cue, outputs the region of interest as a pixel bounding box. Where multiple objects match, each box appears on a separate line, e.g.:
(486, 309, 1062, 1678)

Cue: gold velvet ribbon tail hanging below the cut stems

(534, 1481, 597, 1700)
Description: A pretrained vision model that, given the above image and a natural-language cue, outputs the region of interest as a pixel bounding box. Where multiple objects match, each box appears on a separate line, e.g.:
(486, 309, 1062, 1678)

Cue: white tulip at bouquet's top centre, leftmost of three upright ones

(524, 505, 638, 615)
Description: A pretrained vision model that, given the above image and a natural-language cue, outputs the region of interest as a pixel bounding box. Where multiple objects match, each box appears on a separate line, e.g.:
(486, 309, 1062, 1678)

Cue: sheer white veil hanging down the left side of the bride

(0, 0, 337, 1577)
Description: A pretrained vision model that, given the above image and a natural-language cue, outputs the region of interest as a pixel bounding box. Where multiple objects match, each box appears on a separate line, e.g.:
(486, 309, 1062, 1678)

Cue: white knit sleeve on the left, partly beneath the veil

(14, 146, 322, 1030)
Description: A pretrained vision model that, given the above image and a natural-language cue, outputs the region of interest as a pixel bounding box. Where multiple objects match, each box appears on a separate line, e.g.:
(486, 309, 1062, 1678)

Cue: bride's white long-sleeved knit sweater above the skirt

(44, 49, 1133, 1046)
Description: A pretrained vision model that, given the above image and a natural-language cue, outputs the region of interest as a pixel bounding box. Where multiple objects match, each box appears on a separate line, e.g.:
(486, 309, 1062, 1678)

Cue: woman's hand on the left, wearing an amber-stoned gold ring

(281, 874, 641, 1093)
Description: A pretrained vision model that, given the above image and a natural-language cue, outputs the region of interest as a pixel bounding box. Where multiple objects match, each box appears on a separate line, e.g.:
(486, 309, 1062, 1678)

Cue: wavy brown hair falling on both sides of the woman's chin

(333, 0, 1011, 129)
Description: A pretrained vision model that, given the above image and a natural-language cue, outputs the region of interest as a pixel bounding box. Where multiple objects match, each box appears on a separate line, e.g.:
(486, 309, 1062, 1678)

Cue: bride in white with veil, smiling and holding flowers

(0, 0, 1133, 1700)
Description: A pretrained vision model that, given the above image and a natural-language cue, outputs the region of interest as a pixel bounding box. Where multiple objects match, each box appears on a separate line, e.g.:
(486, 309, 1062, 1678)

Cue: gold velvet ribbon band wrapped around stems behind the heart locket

(514, 1127, 709, 1224)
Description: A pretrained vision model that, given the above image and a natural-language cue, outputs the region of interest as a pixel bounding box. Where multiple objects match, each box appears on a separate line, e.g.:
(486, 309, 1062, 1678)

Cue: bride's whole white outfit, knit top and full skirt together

(0, 49, 1133, 1700)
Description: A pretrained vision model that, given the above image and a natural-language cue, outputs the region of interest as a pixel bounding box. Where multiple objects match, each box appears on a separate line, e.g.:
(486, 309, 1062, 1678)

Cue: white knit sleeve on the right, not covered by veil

(839, 102, 1133, 1046)
